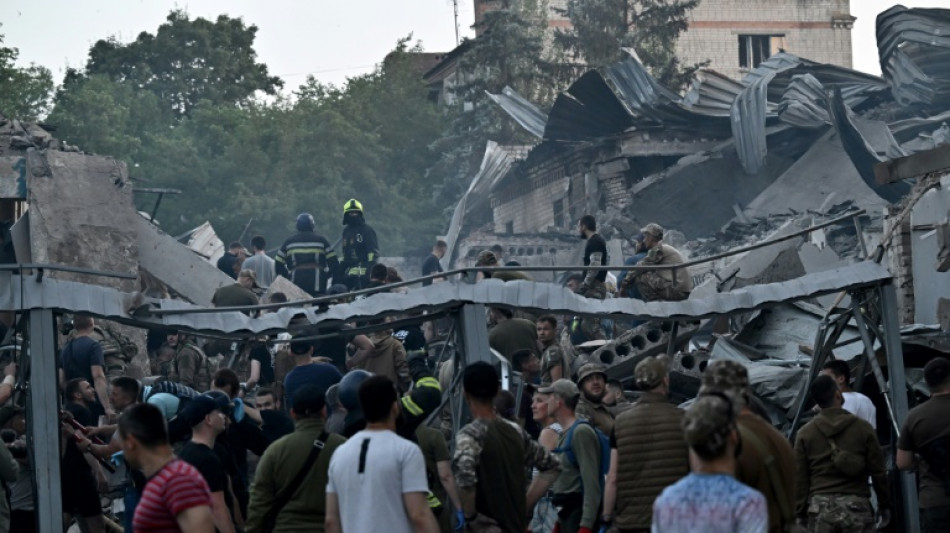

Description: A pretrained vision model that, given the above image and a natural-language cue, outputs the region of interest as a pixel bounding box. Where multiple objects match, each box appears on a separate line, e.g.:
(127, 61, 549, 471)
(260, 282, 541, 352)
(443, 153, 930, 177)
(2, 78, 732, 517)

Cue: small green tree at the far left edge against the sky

(0, 29, 53, 121)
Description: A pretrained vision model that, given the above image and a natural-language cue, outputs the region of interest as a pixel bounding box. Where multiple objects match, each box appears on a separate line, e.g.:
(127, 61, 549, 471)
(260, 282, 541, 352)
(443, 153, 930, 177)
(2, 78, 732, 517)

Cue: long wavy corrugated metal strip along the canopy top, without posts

(0, 262, 891, 335)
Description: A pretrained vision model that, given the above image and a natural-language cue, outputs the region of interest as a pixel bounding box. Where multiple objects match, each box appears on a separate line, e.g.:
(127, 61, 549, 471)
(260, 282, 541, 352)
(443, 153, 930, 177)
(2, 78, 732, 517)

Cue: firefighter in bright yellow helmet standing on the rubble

(340, 199, 379, 291)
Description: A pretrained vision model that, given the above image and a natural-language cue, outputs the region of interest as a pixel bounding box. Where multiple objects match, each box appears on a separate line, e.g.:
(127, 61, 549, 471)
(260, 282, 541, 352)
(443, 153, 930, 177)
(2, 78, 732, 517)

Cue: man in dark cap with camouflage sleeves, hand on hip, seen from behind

(452, 362, 560, 531)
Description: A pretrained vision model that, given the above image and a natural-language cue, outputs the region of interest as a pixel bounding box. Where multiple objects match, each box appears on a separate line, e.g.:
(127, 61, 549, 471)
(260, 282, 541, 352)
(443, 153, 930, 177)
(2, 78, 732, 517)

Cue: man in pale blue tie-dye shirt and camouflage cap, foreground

(652, 394, 769, 533)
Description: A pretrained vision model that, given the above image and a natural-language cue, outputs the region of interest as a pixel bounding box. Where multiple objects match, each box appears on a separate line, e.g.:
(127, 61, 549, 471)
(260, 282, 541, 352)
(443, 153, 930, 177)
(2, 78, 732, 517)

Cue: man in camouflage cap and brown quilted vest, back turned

(602, 356, 689, 533)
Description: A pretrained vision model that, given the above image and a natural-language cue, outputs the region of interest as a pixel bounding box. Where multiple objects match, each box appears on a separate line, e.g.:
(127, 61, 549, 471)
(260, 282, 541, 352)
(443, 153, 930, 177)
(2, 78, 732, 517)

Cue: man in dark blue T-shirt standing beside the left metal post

(59, 315, 115, 421)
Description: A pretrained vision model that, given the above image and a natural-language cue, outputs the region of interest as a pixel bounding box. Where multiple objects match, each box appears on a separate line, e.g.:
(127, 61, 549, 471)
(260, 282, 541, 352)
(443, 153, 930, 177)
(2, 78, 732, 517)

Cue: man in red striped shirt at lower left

(119, 404, 214, 533)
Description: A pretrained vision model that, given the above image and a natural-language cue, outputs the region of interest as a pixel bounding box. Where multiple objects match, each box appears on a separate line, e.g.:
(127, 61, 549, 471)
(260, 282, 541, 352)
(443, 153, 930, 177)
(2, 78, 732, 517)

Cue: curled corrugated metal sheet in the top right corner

(877, 5, 950, 106)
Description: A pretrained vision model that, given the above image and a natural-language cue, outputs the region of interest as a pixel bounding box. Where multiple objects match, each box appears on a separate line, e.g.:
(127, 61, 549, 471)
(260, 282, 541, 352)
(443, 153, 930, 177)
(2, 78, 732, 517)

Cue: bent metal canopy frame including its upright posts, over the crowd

(0, 262, 916, 533)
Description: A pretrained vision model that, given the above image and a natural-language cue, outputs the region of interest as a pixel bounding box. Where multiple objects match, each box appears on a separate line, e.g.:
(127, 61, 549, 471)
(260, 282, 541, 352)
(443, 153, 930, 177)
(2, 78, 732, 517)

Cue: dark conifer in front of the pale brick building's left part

(554, 0, 708, 90)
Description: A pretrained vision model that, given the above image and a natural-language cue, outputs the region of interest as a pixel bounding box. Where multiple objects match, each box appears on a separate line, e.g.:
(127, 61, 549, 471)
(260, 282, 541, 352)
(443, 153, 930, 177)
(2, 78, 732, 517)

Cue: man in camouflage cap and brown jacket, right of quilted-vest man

(699, 359, 795, 533)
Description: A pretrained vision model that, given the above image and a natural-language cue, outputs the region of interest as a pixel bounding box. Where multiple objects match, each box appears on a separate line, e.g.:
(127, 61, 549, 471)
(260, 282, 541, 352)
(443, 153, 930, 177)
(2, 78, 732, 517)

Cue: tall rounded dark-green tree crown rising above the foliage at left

(78, 10, 283, 116)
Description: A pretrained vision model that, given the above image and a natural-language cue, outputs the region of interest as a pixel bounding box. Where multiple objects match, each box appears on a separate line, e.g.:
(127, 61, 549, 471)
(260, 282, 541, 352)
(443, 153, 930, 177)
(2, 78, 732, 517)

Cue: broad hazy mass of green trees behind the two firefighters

(44, 13, 444, 255)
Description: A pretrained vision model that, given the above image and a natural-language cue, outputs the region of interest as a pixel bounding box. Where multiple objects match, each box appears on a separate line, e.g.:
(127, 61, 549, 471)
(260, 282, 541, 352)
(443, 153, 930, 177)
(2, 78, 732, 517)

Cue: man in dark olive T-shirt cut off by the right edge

(897, 357, 950, 533)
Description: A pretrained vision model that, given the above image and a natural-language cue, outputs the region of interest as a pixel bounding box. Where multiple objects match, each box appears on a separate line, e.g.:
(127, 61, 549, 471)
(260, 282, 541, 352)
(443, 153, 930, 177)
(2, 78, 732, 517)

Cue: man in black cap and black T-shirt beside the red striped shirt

(178, 394, 235, 533)
